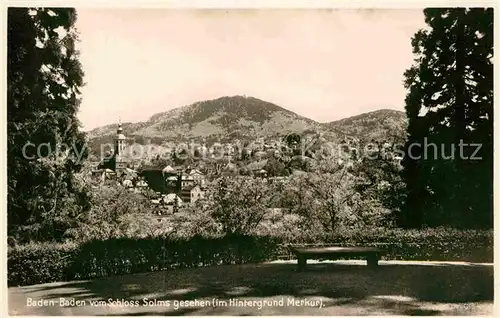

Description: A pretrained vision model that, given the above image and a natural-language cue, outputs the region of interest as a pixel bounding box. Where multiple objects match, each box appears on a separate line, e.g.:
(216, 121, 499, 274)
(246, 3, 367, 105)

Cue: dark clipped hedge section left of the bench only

(8, 236, 279, 286)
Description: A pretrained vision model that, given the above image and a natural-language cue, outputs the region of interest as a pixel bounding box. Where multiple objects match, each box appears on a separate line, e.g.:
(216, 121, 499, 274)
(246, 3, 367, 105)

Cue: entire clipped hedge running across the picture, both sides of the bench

(8, 229, 493, 286)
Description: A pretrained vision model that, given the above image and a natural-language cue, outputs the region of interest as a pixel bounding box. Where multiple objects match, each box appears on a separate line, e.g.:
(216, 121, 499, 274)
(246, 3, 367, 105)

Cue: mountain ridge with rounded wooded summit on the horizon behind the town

(87, 95, 406, 140)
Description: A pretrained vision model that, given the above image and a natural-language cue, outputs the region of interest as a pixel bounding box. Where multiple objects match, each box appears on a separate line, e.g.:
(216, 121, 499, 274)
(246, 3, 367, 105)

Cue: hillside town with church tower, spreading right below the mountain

(91, 123, 401, 216)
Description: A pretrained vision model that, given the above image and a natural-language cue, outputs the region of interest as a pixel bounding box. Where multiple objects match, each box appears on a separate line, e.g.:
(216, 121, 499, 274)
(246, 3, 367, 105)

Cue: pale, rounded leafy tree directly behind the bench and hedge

(284, 160, 389, 233)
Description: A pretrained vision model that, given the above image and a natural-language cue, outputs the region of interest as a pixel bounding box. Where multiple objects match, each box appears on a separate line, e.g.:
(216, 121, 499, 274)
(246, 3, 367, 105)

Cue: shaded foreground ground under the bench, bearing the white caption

(9, 261, 493, 316)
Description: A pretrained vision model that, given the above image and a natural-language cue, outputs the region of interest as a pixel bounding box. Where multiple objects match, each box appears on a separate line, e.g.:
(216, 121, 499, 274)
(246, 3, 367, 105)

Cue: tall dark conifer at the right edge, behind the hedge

(404, 8, 493, 227)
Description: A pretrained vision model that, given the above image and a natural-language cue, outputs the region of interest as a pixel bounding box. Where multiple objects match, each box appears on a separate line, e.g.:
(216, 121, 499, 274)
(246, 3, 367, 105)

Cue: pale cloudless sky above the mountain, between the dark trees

(76, 8, 425, 130)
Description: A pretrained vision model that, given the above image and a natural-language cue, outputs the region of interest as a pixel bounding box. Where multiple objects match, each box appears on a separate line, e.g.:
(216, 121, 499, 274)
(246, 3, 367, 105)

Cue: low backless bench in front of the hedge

(292, 247, 382, 271)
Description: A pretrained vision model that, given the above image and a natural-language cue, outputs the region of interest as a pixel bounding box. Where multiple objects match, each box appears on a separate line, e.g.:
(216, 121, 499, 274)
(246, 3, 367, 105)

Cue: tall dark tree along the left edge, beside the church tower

(7, 8, 89, 239)
